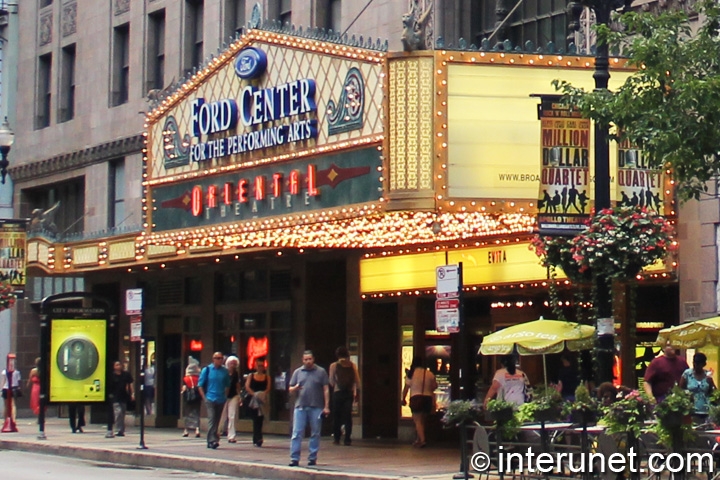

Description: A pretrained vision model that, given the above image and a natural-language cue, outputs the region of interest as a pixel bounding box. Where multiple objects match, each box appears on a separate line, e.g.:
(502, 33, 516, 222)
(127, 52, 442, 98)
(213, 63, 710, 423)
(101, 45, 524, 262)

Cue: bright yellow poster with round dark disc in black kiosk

(49, 319, 107, 403)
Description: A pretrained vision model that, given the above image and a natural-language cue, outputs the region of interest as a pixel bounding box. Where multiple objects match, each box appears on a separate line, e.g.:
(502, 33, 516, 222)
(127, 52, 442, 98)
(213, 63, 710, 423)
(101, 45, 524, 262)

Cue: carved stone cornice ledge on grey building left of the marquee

(8, 134, 143, 183)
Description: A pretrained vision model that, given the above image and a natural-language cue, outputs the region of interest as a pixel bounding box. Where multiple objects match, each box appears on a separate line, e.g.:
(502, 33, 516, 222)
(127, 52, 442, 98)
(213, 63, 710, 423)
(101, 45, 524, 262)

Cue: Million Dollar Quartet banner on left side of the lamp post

(538, 96, 592, 235)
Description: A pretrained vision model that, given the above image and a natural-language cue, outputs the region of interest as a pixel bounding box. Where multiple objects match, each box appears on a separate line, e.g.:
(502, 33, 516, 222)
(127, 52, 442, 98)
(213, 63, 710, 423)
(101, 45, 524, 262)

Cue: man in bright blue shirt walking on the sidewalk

(198, 352, 230, 449)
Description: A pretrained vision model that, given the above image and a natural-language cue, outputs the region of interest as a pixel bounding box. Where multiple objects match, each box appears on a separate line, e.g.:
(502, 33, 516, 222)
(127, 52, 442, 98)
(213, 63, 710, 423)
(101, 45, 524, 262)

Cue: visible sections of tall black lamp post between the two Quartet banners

(568, 0, 633, 385)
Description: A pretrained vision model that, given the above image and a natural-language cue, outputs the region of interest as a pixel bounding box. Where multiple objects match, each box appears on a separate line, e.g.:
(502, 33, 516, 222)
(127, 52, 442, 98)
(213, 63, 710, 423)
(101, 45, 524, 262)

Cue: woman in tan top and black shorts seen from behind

(402, 356, 437, 448)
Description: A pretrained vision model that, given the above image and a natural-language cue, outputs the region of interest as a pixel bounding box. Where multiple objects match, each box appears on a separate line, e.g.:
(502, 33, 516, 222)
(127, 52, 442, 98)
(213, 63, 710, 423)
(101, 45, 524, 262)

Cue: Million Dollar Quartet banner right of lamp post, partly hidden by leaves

(617, 140, 665, 214)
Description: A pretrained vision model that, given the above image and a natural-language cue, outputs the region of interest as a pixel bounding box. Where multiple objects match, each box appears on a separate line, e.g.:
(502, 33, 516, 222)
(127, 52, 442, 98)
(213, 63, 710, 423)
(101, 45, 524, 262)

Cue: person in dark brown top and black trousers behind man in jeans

(328, 346, 360, 445)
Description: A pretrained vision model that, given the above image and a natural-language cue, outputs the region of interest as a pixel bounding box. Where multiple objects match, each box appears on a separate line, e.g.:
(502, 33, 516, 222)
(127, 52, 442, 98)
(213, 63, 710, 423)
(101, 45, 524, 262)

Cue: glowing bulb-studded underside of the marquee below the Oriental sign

(143, 211, 535, 249)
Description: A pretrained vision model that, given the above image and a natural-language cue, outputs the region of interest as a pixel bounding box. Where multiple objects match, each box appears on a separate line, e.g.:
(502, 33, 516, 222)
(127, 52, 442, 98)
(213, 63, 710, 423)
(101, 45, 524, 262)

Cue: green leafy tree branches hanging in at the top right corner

(553, 0, 720, 200)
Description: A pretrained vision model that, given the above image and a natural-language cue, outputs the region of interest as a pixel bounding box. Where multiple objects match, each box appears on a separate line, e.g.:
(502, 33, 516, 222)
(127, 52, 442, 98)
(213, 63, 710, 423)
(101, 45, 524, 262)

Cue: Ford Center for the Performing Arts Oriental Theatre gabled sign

(145, 30, 385, 232)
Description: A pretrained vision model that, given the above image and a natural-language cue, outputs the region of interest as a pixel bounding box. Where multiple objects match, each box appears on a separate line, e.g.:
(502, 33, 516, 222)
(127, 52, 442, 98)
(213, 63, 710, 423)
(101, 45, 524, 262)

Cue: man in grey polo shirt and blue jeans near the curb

(289, 350, 330, 467)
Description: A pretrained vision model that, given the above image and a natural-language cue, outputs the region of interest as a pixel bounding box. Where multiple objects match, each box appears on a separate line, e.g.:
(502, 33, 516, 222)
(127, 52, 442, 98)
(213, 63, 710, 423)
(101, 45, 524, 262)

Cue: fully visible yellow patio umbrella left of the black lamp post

(480, 317, 595, 385)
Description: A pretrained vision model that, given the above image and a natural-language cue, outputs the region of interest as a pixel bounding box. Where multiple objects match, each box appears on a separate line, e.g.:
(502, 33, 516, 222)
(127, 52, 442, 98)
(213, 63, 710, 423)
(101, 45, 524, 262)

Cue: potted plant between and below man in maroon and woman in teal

(654, 385, 694, 449)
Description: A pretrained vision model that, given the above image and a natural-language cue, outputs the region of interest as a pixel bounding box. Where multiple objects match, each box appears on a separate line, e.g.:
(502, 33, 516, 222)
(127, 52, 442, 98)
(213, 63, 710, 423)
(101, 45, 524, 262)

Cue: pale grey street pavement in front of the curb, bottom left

(0, 450, 250, 480)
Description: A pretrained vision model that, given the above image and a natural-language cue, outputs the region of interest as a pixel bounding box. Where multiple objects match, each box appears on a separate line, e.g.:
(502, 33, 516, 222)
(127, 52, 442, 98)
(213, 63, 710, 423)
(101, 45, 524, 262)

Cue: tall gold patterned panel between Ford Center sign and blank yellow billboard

(388, 57, 434, 191)
